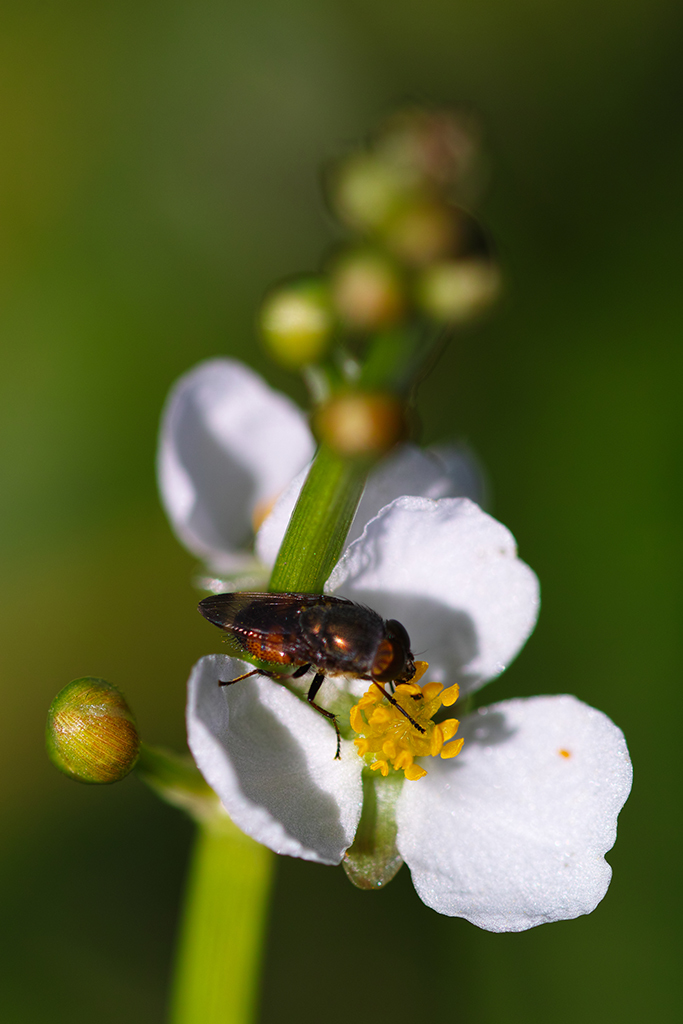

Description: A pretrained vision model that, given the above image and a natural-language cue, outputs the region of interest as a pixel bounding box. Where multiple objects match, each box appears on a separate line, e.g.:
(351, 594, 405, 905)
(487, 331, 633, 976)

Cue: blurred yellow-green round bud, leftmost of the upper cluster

(259, 279, 334, 370)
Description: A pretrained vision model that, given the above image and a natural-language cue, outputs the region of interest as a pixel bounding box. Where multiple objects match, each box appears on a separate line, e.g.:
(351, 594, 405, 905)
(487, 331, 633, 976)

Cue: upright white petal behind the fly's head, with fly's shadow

(326, 498, 539, 693)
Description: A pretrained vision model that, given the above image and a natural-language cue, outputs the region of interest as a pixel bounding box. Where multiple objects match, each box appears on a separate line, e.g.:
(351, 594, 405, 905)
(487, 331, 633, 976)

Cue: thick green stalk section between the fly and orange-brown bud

(268, 444, 370, 594)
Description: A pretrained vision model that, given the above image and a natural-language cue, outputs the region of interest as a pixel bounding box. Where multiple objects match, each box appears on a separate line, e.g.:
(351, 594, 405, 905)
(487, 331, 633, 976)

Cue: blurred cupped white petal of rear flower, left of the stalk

(158, 359, 313, 569)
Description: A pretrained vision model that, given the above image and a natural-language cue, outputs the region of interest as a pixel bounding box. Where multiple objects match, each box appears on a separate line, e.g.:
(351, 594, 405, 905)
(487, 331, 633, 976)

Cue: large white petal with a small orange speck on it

(396, 696, 632, 932)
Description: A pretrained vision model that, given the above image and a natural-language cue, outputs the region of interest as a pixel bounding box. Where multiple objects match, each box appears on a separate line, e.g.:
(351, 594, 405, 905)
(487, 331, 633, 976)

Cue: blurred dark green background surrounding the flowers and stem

(0, 0, 683, 1024)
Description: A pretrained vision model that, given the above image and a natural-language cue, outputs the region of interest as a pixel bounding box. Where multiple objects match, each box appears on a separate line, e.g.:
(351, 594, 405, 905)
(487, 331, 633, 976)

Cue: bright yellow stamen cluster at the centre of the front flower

(351, 665, 463, 781)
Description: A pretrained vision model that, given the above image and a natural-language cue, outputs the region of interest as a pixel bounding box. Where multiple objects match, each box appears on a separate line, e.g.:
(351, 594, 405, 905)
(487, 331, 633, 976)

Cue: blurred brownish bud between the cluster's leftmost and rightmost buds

(330, 249, 405, 331)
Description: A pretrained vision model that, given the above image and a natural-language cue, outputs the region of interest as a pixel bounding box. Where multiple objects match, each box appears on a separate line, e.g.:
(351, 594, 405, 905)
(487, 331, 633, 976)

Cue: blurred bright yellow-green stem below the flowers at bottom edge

(170, 823, 273, 1024)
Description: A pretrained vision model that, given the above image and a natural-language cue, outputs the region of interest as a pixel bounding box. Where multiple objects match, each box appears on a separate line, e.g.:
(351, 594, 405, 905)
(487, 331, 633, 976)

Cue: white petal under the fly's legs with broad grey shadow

(187, 654, 362, 864)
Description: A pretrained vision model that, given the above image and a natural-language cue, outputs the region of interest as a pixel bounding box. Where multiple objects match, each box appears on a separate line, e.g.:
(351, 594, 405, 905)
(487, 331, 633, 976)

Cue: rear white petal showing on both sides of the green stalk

(256, 444, 485, 565)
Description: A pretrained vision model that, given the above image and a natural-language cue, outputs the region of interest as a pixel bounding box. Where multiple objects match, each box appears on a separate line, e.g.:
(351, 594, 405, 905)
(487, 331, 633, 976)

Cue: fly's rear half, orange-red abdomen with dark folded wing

(199, 592, 350, 667)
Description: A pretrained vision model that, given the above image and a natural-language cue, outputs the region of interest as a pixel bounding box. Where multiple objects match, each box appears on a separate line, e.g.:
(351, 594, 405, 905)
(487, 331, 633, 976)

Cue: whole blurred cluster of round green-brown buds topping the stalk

(259, 109, 500, 457)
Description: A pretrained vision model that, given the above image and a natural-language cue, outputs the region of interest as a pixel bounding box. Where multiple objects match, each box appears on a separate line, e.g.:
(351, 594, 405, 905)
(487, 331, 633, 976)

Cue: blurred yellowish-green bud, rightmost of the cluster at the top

(417, 258, 501, 324)
